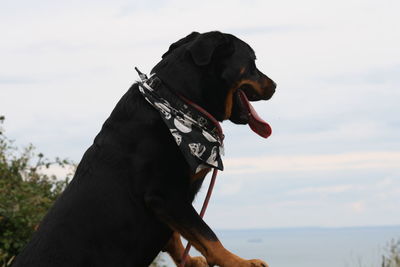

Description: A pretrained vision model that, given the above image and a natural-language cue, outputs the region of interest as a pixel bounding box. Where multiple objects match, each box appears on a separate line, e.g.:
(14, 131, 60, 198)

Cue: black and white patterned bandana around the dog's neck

(138, 73, 224, 174)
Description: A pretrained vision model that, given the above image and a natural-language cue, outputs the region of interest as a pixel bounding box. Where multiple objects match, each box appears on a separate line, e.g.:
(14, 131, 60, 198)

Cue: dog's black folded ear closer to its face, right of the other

(187, 31, 233, 66)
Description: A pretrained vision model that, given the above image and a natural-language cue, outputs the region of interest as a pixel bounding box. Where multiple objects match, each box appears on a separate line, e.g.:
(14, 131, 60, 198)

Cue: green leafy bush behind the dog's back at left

(0, 116, 73, 266)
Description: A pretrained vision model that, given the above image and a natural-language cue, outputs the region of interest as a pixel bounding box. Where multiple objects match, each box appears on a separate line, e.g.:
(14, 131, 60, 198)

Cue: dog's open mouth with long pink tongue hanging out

(230, 87, 272, 138)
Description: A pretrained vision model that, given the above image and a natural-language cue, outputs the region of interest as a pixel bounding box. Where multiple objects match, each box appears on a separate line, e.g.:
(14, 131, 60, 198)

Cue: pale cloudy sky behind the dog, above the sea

(0, 0, 400, 229)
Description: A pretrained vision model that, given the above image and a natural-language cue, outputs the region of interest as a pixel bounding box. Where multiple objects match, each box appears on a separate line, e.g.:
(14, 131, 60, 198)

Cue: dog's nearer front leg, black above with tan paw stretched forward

(145, 192, 267, 267)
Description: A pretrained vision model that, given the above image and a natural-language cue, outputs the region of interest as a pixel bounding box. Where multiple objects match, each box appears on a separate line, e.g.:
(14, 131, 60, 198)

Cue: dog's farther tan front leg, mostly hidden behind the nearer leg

(163, 232, 209, 267)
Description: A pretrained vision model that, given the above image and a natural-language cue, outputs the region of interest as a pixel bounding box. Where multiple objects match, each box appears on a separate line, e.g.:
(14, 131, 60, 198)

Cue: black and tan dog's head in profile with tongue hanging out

(152, 32, 276, 137)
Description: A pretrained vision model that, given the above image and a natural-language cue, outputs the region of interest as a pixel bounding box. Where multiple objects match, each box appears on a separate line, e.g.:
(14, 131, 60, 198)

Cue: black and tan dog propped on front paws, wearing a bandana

(13, 32, 276, 267)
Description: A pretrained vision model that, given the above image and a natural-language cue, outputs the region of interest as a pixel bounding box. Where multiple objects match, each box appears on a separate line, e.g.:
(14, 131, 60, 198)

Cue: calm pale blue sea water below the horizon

(161, 226, 400, 267)
